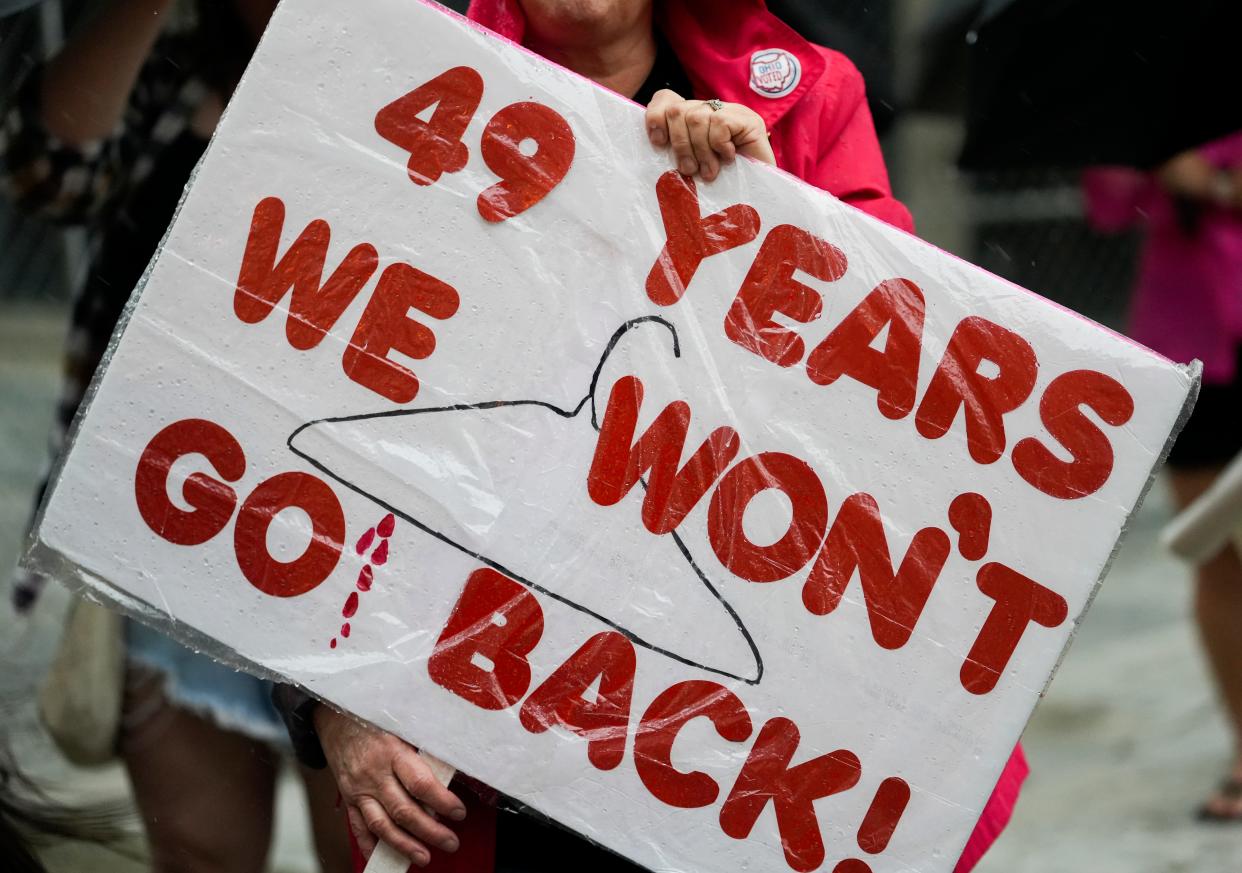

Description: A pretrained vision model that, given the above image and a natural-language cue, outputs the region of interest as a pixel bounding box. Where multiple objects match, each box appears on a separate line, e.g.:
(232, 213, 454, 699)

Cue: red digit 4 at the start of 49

(375, 67, 483, 185)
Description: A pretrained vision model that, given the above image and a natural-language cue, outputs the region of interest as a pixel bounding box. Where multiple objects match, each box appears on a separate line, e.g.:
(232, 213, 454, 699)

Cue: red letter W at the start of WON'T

(586, 376, 740, 534)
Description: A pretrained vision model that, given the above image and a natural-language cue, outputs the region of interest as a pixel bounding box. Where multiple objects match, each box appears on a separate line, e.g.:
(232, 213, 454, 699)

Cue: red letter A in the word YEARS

(806, 279, 924, 418)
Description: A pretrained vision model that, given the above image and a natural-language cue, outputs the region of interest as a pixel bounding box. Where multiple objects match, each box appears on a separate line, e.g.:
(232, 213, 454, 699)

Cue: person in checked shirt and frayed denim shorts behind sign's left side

(0, 0, 348, 873)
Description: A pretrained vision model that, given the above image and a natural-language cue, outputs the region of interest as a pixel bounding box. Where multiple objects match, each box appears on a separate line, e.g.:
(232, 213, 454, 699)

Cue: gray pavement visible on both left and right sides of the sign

(0, 296, 1242, 873)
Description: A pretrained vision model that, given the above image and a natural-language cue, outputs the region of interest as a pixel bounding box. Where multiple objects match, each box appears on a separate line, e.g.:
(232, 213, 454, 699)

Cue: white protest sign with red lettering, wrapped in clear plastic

(21, 0, 1197, 873)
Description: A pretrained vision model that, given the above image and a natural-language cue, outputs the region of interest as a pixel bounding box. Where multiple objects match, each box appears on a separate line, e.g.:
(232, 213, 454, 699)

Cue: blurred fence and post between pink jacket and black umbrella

(884, 0, 1139, 328)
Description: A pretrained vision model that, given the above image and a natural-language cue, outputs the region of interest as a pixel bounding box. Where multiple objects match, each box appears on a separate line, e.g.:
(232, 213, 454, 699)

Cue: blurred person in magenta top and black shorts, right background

(1083, 132, 1242, 821)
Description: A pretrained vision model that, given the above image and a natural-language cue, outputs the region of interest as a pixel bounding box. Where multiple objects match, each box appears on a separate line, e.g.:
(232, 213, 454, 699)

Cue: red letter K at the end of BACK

(720, 718, 862, 871)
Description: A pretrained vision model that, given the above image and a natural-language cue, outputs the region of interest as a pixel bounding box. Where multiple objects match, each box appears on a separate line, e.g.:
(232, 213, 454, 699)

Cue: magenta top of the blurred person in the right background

(1083, 132, 1242, 384)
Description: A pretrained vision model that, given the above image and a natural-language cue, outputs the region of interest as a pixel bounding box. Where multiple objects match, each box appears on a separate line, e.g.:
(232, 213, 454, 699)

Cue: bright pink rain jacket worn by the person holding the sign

(355, 0, 1027, 873)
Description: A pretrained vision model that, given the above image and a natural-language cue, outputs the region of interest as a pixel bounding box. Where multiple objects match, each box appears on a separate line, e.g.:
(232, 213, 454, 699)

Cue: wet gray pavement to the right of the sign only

(979, 484, 1242, 873)
